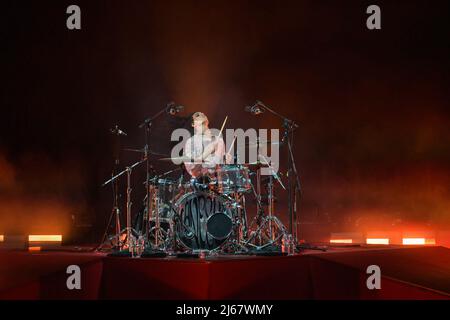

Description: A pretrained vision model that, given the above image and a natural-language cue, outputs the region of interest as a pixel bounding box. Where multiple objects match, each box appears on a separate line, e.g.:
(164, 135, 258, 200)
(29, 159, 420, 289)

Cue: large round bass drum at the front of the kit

(174, 191, 235, 250)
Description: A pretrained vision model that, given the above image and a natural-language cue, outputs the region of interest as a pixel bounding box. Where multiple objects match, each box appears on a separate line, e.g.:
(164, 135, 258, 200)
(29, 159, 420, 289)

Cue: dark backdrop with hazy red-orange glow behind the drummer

(0, 0, 450, 241)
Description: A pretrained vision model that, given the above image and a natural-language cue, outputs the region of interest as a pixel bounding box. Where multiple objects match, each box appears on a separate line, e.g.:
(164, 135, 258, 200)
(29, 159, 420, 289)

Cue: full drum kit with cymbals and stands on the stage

(97, 101, 298, 257)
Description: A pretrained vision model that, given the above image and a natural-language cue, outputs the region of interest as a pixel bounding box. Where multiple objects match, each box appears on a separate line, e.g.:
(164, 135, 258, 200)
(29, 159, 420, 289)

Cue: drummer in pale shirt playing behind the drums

(183, 112, 232, 179)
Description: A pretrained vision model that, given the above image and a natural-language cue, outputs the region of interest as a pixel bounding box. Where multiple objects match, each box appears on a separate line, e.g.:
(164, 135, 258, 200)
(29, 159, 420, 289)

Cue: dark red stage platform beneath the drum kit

(0, 247, 450, 300)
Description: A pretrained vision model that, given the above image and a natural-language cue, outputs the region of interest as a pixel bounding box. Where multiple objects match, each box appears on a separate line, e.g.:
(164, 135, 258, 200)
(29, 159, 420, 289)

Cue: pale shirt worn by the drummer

(183, 134, 225, 177)
